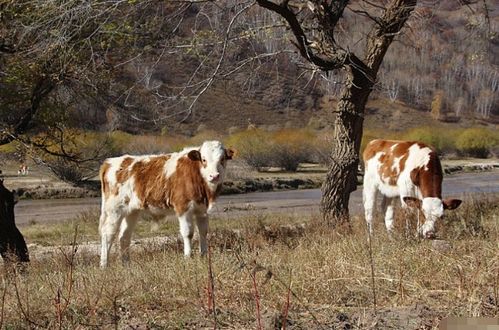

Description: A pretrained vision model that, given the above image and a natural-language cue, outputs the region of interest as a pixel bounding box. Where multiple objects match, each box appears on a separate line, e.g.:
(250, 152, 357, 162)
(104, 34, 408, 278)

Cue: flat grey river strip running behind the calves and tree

(16, 170, 499, 226)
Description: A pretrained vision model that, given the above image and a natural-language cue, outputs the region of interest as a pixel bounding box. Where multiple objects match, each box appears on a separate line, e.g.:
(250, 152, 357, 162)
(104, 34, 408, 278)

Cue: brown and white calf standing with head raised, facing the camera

(99, 141, 233, 267)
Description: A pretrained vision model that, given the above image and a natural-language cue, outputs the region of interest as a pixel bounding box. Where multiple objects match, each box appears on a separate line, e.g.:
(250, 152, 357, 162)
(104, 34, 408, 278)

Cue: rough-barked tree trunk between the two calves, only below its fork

(321, 61, 374, 226)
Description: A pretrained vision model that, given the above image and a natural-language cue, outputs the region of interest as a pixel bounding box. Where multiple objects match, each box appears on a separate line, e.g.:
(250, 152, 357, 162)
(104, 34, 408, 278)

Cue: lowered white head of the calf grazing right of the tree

(403, 197, 462, 239)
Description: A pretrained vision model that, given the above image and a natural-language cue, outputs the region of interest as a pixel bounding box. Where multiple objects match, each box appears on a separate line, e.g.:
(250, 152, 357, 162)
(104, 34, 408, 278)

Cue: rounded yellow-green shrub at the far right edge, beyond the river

(456, 128, 499, 158)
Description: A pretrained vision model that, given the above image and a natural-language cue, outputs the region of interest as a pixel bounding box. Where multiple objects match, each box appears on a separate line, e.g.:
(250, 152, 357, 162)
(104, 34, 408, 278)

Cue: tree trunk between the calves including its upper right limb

(321, 0, 417, 226)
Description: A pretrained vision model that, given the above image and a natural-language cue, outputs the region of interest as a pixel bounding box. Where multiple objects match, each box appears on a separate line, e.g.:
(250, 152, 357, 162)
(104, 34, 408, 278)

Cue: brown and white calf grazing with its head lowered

(362, 140, 461, 238)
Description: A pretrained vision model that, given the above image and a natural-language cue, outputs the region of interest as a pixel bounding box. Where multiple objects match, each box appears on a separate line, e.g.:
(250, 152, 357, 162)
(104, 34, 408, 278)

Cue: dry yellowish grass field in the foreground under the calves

(0, 192, 499, 329)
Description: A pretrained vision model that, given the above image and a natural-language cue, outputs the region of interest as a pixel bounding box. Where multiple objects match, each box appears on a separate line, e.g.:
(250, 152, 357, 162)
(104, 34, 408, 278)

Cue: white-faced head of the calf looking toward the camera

(188, 141, 234, 185)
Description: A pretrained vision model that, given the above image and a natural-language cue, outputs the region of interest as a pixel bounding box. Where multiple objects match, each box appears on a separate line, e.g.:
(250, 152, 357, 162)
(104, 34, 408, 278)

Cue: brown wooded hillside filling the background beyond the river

(0, 0, 499, 138)
